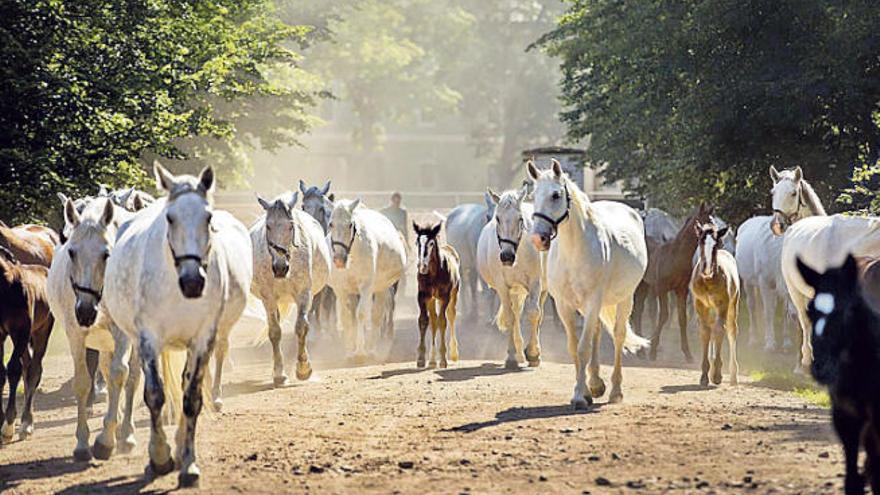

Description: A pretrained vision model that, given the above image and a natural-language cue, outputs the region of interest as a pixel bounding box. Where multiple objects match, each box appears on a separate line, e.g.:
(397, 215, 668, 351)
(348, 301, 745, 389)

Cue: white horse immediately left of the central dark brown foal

(330, 199, 406, 356)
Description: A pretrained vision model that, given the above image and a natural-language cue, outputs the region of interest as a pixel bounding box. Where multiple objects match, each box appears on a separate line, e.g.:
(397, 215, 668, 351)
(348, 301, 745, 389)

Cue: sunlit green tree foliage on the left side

(0, 0, 317, 221)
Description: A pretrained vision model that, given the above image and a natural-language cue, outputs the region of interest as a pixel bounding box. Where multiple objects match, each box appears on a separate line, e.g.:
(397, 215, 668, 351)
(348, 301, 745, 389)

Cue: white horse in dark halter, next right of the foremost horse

(251, 193, 330, 386)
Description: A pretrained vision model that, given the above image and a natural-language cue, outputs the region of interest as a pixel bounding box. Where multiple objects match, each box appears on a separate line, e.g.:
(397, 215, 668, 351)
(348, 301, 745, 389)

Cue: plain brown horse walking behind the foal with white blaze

(635, 203, 712, 363)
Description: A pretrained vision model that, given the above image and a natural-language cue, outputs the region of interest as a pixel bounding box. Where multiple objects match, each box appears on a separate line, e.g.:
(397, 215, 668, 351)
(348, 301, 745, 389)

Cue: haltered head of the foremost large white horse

(153, 162, 214, 299)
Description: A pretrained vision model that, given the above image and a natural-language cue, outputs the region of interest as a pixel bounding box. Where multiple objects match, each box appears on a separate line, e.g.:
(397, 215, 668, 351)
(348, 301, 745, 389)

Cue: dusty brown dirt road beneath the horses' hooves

(0, 310, 843, 494)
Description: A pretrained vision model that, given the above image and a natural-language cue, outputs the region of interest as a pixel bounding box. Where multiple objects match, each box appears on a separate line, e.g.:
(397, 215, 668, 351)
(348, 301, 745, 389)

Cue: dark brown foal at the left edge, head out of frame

(0, 246, 55, 443)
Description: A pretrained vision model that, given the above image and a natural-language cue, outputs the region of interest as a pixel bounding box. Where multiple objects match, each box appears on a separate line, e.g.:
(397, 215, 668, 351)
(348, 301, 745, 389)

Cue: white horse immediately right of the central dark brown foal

(477, 188, 547, 369)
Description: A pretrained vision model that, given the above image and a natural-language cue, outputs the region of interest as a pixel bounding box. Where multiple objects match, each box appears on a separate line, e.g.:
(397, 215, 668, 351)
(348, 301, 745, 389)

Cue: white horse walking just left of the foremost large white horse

(47, 197, 144, 461)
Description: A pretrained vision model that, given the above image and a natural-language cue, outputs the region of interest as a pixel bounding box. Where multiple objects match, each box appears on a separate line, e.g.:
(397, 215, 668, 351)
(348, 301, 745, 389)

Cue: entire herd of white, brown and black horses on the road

(0, 160, 880, 493)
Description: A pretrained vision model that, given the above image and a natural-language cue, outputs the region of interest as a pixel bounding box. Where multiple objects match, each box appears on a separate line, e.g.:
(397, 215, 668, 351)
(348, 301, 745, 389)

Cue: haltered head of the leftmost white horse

(64, 198, 116, 328)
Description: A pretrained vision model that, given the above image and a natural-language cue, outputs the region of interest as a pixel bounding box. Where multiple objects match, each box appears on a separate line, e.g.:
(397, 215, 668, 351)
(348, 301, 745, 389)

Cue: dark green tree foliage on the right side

(542, 0, 880, 221)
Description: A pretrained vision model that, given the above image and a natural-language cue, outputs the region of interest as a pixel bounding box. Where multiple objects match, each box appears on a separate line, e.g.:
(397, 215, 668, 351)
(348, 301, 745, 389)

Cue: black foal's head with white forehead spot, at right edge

(797, 255, 871, 385)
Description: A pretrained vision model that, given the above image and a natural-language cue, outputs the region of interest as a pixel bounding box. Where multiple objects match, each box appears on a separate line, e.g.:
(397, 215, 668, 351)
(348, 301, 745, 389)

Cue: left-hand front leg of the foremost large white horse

(138, 331, 174, 476)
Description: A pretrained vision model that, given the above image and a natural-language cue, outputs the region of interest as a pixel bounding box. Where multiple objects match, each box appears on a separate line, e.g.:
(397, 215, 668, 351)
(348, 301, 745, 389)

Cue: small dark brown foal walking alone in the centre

(413, 222, 461, 368)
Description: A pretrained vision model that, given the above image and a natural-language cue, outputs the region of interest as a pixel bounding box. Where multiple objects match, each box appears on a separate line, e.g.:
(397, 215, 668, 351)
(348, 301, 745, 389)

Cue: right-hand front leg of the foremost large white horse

(177, 334, 216, 488)
